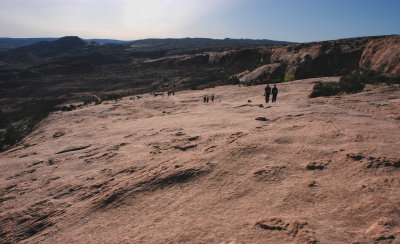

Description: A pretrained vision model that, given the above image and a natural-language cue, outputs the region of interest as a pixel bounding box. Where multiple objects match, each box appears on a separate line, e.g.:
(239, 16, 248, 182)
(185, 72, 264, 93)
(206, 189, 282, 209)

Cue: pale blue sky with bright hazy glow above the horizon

(0, 0, 400, 42)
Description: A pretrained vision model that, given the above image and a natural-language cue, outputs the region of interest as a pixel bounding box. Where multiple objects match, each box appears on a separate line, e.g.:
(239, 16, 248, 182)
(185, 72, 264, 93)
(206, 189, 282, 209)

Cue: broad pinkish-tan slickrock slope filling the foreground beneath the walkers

(0, 78, 400, 243)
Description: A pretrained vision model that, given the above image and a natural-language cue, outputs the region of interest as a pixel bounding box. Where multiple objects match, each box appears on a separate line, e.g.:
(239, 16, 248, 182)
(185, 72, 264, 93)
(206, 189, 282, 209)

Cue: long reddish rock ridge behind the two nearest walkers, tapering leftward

(141, 35, 400, 87)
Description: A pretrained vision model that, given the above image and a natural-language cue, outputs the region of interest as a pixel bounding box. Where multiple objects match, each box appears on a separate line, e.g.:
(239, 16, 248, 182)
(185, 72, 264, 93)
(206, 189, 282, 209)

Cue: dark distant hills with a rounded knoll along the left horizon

(0, 36, 294, 66)
